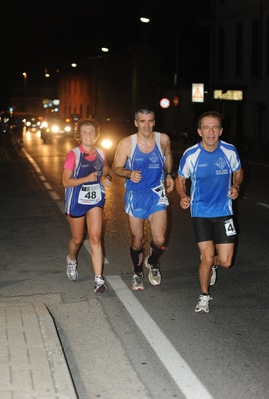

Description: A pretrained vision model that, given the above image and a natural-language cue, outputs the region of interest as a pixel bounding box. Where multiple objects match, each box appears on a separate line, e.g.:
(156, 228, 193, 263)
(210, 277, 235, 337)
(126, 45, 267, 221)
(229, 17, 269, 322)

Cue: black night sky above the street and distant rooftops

(0, 0, 210, 109)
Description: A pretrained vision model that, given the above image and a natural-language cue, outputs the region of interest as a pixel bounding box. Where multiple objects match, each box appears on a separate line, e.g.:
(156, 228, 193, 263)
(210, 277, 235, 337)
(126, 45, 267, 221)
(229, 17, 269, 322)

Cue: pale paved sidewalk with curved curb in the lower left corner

(0, 147, 77, 399)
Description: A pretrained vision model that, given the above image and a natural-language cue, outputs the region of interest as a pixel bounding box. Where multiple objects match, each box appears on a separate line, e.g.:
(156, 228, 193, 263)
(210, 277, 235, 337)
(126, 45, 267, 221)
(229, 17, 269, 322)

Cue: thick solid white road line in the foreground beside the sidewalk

(106, 276, 213, 399)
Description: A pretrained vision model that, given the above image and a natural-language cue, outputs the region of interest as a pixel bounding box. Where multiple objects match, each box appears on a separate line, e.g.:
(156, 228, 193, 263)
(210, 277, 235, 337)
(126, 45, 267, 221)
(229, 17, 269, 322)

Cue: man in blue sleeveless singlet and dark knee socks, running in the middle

(112, 107, 174, 291)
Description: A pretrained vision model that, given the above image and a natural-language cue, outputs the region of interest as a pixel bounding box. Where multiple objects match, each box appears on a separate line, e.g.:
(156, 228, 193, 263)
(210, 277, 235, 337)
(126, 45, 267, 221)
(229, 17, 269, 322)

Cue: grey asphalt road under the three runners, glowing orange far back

(0, 133, 269, 399)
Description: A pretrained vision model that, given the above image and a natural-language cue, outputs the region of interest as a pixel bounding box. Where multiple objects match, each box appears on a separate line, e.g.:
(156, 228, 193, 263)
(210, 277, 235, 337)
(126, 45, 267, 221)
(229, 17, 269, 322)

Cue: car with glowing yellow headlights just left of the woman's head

(40, 115, 73, 143)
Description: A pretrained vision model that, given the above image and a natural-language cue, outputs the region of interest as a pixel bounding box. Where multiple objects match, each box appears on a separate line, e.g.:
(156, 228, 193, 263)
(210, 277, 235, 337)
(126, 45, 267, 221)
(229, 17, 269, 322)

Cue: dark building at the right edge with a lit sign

(211, 0, 269, 152)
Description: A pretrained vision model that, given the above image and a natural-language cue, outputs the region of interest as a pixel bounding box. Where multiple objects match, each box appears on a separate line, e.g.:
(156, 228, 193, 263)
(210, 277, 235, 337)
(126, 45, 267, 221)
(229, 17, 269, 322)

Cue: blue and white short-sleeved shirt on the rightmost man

(178, 140, 241, 218)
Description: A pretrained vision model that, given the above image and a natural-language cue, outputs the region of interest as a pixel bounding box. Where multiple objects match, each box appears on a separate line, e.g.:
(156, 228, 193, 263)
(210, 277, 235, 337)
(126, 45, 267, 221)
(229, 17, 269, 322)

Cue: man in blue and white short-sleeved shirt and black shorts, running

(176, 111, 243, 313)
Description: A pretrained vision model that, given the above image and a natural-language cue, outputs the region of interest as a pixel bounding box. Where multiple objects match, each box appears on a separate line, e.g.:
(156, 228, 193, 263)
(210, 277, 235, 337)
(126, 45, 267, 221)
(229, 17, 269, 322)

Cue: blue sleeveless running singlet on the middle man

(125, 132, 165, 191)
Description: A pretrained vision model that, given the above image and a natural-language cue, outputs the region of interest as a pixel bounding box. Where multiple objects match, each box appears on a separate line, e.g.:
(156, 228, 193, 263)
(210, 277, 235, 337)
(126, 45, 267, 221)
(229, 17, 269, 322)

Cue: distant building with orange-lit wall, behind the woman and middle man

(59, 47, 158, 122)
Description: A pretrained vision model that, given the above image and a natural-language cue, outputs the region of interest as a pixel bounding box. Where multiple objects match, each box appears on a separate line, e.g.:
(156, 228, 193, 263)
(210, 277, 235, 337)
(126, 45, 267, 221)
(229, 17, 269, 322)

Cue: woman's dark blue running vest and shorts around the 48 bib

(65, 147, 106, 217)
